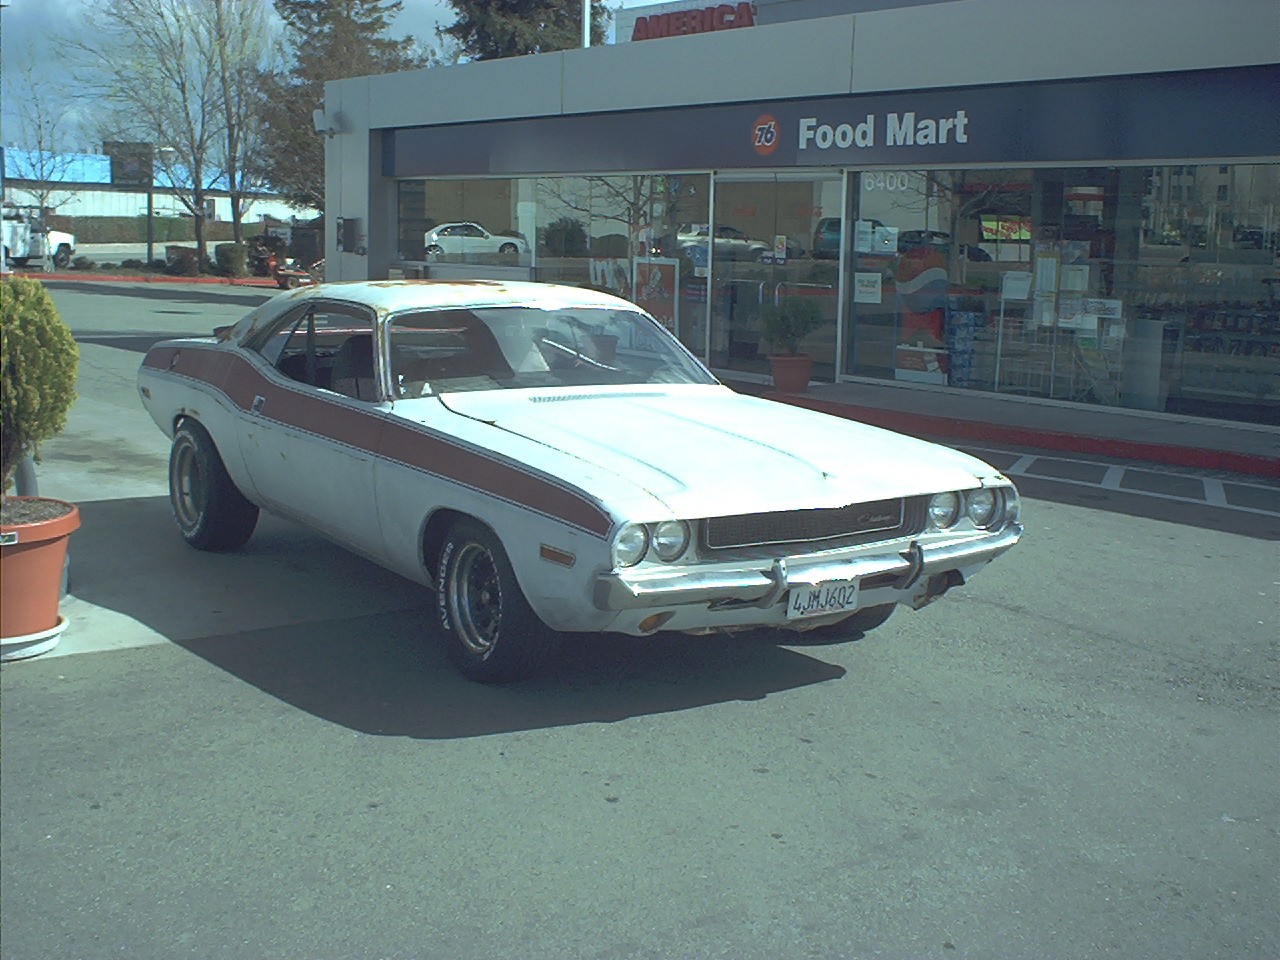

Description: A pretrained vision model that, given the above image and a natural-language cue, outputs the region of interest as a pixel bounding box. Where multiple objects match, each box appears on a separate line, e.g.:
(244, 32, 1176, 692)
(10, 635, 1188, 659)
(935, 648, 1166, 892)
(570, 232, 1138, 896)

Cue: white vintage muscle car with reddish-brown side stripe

(138, 280, 1023, 681)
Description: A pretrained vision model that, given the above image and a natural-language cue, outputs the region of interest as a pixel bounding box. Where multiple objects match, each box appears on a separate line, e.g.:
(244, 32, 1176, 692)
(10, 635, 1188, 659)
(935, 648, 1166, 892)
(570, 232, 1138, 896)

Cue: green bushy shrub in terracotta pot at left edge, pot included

(0, 276, 79, 660)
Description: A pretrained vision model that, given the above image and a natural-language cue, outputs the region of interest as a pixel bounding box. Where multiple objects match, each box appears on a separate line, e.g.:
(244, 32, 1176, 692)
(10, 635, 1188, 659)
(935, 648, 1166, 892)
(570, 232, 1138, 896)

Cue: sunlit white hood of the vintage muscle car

(440, 385, 997, 518)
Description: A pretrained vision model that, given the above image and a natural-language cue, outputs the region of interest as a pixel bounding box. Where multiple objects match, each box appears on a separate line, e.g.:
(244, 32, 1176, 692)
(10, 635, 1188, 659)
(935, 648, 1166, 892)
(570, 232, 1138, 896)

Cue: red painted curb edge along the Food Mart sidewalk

(765, 393, 1280, 477)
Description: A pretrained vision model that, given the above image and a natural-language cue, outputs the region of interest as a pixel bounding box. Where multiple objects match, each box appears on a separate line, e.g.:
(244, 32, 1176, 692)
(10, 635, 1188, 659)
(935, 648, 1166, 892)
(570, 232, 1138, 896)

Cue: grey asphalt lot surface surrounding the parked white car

(0, 282, 1280, 960)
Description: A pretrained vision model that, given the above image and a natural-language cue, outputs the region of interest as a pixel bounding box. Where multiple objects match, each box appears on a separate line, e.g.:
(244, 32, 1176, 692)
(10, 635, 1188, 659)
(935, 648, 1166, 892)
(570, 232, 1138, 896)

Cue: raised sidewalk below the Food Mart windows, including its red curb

(721, 371, 1280, 479)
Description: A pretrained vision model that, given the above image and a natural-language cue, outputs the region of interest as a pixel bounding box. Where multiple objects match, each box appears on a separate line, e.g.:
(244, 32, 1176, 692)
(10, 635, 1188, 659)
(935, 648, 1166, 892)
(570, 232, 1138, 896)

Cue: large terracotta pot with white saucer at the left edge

(0, 497, 79, 660)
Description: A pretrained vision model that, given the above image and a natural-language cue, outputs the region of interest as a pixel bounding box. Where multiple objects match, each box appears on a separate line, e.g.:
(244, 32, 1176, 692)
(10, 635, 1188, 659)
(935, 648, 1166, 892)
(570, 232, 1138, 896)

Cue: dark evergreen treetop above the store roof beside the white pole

(439, 0, 609, 60)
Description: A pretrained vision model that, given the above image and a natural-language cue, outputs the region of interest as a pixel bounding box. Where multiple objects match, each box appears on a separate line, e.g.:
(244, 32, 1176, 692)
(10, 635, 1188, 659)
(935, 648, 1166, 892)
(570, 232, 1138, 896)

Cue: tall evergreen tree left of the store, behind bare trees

(260, 0, 433, 210)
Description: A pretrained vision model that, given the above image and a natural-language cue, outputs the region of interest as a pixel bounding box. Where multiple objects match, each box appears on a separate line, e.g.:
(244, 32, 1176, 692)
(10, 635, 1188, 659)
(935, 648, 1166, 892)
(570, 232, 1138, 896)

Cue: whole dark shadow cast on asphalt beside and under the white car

(70, 497, 845, 739)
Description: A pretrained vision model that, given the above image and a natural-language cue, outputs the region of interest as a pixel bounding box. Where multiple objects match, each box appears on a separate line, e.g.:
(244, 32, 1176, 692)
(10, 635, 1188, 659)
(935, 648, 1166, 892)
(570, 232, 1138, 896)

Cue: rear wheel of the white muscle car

(169, 420, 257, 550)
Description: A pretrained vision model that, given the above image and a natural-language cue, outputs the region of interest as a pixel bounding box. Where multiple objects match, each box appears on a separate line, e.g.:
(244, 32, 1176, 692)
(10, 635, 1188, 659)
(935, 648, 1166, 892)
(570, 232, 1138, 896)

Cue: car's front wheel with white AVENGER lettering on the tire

(435, 520, 558, 684)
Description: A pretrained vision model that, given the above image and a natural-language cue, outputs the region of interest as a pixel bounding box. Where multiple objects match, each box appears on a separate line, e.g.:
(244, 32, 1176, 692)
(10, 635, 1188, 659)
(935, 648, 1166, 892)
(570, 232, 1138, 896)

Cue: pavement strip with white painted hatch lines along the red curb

(956, 444, 1280, 517)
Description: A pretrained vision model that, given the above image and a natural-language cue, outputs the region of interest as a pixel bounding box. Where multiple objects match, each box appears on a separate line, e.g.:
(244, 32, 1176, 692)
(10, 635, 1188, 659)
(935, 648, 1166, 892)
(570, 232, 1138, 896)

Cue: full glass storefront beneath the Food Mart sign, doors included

(398, 164, 1280, 422)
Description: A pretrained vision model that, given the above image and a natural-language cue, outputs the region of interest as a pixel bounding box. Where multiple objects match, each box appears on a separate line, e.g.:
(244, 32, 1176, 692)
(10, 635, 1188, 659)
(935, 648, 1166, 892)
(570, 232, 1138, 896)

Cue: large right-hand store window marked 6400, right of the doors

(845, 164, 1280, 422)
